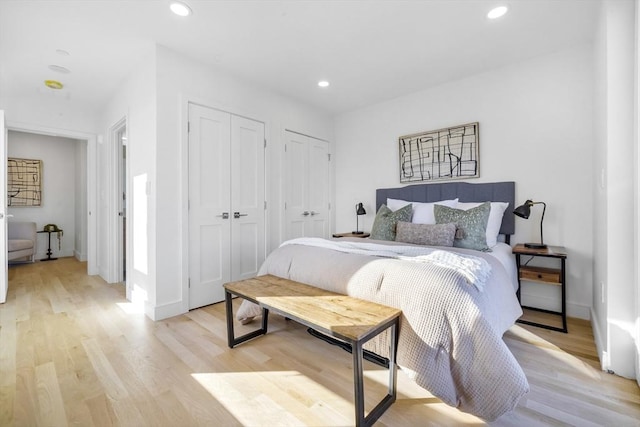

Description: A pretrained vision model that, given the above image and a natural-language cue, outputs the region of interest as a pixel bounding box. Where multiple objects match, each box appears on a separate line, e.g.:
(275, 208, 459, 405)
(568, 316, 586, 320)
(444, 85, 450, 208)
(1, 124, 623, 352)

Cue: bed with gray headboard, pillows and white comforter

(237, 182, 529, 421)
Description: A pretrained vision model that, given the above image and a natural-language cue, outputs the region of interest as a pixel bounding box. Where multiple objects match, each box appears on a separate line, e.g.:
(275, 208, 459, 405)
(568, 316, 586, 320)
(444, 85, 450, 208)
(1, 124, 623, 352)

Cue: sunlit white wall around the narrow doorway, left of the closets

(98, 47, 158, 317)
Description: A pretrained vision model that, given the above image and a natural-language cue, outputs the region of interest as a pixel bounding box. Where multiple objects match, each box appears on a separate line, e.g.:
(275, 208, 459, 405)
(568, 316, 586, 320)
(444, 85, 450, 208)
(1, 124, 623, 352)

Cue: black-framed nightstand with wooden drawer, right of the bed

(512, 244, 567, 333)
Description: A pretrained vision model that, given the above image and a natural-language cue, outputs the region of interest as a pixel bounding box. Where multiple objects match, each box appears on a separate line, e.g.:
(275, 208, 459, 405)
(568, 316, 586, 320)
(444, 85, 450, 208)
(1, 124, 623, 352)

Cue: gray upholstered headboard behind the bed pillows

(376, 182, 516, 241)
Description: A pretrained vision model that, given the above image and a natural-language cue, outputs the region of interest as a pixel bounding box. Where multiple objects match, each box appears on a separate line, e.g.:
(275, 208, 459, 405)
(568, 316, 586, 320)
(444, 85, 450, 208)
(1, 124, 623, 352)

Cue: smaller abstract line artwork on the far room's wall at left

(7, 157, 42, 207)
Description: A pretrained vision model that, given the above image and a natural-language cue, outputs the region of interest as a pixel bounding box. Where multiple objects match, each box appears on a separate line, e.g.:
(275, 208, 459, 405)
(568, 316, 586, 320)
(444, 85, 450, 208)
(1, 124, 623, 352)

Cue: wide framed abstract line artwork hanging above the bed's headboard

(398, 122, 480, 182)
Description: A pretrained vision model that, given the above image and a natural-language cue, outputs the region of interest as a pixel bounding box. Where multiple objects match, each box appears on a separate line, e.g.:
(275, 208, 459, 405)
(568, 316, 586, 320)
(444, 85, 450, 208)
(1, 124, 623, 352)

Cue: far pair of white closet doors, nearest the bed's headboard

(285, 132, 330, 239)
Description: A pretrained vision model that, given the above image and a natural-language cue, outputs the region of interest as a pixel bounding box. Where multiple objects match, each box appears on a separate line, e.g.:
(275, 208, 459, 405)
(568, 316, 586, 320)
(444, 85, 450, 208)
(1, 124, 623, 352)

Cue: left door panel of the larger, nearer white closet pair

(189, 105, 233, 309)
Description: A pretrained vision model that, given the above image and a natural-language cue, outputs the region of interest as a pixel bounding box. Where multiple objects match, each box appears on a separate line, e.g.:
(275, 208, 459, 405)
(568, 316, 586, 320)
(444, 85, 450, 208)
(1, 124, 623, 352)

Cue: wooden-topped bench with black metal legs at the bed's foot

(224, 275, 401, 426)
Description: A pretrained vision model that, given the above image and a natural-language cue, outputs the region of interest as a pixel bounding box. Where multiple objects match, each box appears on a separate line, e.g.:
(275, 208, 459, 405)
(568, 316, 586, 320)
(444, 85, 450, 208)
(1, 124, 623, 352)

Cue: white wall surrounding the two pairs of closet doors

(152, 46, 333, 318)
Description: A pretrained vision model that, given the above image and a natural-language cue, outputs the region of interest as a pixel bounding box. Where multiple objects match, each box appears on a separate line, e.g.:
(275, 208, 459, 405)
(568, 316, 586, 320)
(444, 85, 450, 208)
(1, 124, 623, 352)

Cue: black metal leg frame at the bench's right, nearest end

(351, 318, 399, 427)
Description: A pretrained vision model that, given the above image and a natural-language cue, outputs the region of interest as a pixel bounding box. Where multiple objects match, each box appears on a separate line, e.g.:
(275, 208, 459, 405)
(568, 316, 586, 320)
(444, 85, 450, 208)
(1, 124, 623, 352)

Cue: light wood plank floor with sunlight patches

(0, 258, 640, 427)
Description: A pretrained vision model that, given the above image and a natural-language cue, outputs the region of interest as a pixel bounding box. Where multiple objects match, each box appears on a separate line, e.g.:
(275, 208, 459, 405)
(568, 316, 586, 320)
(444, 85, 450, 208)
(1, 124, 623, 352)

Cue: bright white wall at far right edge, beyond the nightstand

(592, 0, 638, 378)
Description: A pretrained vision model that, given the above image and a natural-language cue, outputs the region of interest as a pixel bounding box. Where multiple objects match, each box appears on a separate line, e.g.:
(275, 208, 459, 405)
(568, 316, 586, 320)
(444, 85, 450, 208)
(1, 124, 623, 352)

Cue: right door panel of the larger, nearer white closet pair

(230, 116, 266, 280)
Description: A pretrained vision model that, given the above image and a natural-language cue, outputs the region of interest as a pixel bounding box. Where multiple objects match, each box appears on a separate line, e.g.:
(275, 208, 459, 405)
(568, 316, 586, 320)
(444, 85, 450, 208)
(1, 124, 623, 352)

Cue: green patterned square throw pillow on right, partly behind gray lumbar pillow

(433, 202, 491, 251)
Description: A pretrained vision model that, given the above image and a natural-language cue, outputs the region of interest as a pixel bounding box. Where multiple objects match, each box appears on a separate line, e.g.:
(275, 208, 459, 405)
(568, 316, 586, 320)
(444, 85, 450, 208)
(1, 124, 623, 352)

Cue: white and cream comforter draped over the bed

(237, 239, 529, 420)
